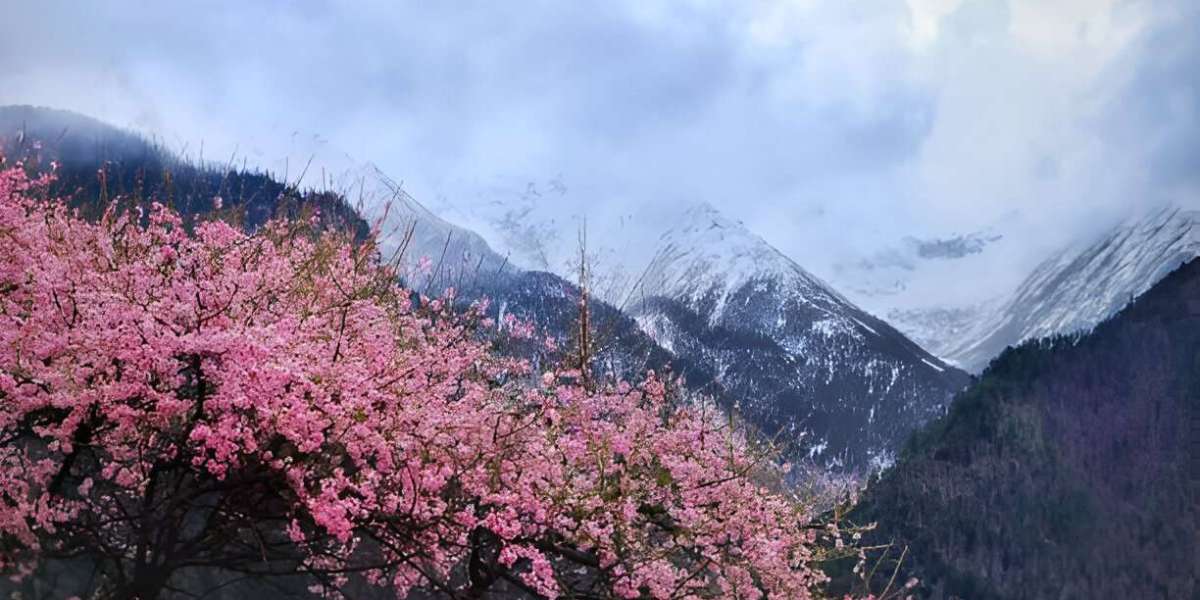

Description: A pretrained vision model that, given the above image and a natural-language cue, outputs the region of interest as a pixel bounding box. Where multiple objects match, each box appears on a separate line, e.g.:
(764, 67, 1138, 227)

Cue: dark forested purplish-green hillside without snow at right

(839, 260, 1200, 600)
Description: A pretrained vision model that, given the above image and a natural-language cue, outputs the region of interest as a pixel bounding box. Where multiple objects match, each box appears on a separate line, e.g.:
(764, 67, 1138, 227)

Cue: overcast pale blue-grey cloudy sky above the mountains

(0, 0, 1200, 310)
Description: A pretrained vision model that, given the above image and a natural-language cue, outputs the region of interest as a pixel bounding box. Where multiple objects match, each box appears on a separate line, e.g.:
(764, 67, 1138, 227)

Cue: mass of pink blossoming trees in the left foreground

(0, 162, 840, 599)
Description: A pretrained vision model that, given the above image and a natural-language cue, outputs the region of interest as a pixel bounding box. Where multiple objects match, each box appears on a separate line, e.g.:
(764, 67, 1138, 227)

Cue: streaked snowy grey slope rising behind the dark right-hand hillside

(916, 208, 1200, 372)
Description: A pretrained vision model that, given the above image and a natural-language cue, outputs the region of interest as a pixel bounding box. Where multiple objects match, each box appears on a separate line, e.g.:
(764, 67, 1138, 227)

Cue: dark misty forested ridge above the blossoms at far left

(0, 106, 368, 239)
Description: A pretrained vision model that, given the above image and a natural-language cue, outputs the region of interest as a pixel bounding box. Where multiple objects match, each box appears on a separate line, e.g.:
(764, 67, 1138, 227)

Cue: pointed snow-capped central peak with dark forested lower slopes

(626, 205, 966, 468)
